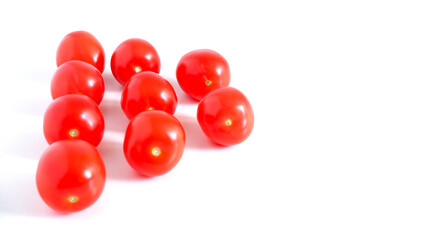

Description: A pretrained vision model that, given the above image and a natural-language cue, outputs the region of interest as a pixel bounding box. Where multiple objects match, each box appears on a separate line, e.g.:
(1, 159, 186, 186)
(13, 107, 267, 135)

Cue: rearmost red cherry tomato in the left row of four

(56, 31, 105, 73)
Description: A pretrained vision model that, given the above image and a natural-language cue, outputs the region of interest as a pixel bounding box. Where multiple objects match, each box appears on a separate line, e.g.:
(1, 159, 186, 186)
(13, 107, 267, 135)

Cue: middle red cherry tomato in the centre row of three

(120, 72, 177, 119)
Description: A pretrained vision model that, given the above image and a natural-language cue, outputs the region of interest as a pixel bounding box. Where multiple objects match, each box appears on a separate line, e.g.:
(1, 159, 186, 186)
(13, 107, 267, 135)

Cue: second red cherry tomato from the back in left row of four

(50, 60, 105, 104)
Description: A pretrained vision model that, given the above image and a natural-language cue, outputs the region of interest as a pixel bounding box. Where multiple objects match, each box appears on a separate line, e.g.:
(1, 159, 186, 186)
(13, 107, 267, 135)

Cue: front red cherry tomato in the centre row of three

(123, 110, 186, 177)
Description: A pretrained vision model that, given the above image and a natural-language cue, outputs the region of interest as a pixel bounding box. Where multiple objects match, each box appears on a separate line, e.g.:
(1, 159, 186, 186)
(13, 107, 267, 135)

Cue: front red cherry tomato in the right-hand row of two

(197, 87, 254, 145)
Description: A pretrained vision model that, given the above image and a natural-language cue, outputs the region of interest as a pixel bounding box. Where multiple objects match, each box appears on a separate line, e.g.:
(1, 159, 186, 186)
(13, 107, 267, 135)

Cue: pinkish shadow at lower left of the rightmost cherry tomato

(175, 114, 226, 150)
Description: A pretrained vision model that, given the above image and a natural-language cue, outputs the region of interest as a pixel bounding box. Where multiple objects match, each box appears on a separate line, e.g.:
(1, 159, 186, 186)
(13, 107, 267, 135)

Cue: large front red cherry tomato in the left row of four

(36, 140, 106, 212)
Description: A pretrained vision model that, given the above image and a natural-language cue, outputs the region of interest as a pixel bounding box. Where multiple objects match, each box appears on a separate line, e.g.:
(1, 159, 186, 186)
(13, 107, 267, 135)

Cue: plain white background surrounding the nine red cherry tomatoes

(0, 0, 439, 239)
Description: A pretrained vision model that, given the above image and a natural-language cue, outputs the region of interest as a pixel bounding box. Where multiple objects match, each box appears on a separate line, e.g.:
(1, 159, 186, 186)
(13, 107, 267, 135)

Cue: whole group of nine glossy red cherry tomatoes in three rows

(36, 31, 254, 212)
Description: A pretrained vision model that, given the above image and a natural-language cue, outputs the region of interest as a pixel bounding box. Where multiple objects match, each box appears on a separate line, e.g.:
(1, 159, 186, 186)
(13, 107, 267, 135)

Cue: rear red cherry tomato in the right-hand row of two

(177, 49, 230, 101)
